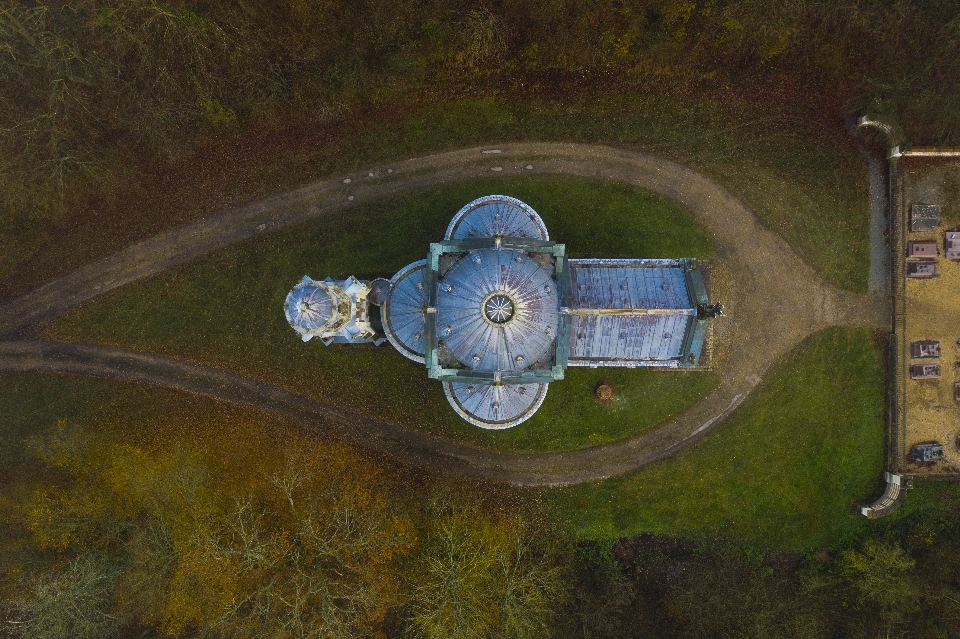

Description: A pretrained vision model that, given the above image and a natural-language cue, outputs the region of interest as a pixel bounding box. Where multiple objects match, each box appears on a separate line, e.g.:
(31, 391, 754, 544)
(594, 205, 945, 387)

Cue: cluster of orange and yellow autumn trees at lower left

(0, 415, 566, 639)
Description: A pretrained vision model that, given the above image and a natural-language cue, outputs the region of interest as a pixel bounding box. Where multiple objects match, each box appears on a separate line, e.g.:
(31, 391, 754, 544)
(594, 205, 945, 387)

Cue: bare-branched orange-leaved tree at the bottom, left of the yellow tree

(198, 455, 412, 639)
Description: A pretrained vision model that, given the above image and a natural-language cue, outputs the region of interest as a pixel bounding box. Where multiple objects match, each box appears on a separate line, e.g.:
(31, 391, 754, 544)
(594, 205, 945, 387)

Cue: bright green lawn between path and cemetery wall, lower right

(544, 328, 885, 549)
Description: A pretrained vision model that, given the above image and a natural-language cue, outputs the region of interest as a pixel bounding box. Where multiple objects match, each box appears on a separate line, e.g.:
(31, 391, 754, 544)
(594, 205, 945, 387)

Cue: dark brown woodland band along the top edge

(0, 0, 960, 272)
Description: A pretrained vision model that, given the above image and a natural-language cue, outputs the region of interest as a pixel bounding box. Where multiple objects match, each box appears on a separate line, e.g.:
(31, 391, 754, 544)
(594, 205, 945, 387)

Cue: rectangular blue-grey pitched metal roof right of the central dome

(568, 259, 708, 368)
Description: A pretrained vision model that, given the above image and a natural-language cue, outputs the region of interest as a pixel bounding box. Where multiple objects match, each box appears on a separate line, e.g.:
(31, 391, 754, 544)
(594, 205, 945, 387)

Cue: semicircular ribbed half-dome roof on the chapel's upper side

(444, 195, 550, 241)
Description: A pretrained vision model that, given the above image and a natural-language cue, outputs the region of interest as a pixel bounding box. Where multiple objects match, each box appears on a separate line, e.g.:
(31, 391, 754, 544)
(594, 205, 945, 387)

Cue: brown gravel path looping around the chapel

(0, 144, 889, 485)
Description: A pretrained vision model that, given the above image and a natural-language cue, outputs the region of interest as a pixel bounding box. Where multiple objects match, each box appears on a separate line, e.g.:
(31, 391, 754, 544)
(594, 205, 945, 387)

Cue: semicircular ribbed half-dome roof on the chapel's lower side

(443, 382, 547, 429)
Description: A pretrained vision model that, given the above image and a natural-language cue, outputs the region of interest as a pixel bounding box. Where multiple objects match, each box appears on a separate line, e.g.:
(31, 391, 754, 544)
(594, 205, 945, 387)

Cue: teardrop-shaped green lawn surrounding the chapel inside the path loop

(46, 176, 719, 451)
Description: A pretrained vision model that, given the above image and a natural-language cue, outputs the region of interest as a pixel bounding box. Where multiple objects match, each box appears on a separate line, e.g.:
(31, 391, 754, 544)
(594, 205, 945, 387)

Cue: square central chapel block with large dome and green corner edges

(424, 237, 568, 384)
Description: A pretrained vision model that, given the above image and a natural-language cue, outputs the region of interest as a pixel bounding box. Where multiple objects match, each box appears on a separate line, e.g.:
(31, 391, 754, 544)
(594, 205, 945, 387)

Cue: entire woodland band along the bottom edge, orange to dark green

(0, 420, 960, 639)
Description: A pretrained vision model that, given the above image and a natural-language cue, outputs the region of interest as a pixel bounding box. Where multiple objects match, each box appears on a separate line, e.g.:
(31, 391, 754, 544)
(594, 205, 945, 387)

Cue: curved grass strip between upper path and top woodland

(0, 91, 869, 296)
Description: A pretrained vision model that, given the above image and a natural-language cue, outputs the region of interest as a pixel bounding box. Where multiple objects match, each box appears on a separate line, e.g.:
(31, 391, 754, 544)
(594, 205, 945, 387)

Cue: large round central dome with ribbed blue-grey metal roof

(434, 248, 559, 372)
